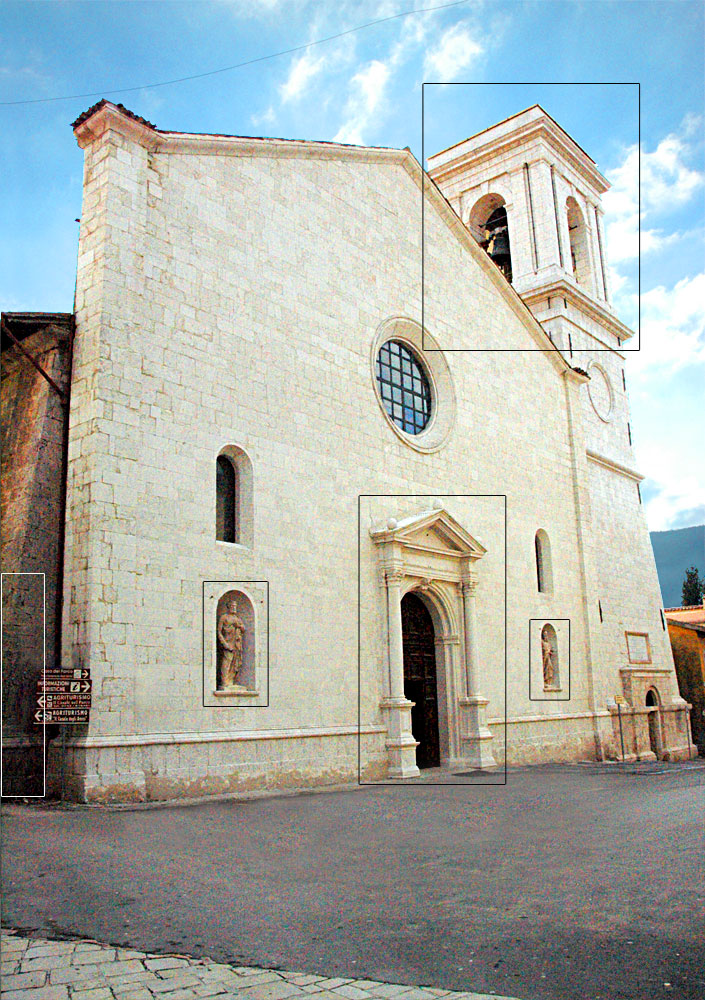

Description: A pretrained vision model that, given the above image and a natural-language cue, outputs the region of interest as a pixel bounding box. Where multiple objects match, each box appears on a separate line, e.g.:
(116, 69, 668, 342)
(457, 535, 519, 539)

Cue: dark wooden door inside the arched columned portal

(401, 593, 441, 768)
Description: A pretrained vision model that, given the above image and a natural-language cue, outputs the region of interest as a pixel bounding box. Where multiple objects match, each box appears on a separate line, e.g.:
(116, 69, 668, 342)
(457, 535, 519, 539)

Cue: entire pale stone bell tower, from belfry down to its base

(428, 104, 687, 743)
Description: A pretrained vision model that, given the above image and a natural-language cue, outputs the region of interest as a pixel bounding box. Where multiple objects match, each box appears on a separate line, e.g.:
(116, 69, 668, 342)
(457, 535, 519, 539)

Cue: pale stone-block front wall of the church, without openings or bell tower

(56, 105, 692, 799)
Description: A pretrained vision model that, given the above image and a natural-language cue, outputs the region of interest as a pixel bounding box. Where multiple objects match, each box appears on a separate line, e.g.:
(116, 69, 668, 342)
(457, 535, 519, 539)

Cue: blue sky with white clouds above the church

(0, 0, 705, 530)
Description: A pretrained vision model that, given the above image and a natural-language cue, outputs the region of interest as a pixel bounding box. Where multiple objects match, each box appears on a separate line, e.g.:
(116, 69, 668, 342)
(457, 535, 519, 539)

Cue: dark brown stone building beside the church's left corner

(0, 313, 73, 795)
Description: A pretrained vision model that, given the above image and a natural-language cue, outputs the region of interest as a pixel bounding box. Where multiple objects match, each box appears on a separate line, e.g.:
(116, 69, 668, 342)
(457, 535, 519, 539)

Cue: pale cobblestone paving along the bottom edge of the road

(0, 930, 516, 1000)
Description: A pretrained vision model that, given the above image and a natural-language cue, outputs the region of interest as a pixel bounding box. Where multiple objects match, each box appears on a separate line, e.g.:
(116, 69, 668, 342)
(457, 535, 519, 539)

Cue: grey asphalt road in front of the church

(1, 764, 705, 1000)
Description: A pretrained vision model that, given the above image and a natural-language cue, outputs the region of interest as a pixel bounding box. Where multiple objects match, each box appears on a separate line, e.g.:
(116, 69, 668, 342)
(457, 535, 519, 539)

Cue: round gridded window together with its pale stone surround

(370, 316, 455, 453)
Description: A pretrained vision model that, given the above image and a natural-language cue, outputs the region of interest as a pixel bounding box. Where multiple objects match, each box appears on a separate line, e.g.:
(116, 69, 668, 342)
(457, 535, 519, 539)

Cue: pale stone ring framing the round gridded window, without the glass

(370, 316, 456, 454)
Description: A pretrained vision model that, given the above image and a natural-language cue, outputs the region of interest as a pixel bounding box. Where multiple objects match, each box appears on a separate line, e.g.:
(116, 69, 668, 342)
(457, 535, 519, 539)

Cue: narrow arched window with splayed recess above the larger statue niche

(215, 444, 254, 549)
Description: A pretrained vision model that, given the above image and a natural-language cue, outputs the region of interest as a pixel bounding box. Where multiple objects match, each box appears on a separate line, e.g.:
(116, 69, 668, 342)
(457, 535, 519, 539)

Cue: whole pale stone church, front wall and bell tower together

(2, 101, 692, 801)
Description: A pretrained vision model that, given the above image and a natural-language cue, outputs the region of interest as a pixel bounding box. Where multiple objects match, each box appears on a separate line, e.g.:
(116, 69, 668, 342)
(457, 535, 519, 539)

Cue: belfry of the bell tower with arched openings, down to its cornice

(428, 104, 632, 356)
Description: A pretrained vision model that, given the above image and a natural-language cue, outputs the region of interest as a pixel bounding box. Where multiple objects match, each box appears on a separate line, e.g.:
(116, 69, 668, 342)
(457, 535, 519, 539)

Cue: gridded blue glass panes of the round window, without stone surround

(376, 340, 431, 434)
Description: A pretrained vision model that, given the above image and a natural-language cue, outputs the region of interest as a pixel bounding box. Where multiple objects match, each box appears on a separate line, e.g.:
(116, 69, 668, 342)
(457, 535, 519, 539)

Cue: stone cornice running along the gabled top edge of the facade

(74, 100, 587, 382)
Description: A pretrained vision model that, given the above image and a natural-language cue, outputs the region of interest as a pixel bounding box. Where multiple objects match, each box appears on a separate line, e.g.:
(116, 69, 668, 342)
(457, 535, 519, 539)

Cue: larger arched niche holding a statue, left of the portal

(213, 590, 257, 693)
